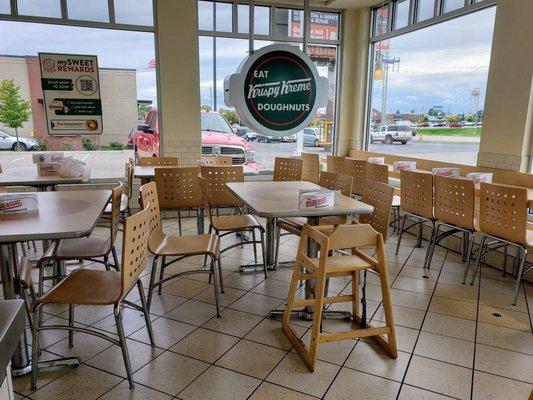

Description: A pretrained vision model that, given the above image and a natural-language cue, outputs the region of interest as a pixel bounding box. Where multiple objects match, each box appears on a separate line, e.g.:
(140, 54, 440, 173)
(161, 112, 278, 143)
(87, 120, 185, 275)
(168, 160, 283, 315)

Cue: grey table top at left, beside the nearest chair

(0, 190, 111, 243)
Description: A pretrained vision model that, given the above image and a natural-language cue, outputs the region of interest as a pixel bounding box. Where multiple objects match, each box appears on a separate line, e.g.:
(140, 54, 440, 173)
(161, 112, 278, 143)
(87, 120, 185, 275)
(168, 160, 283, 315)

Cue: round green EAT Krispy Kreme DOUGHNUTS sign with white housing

(224, 44, 328, 136)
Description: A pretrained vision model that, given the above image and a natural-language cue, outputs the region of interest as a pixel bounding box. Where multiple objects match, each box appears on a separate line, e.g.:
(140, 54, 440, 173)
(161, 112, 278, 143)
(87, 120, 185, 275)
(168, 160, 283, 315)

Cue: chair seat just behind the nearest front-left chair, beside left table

(43, 235, 111, 260)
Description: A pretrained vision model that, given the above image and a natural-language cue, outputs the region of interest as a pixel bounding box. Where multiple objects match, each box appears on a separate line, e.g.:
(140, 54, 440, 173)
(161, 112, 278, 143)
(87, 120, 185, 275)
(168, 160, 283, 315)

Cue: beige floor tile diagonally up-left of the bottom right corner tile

(414, 332, 474, 368)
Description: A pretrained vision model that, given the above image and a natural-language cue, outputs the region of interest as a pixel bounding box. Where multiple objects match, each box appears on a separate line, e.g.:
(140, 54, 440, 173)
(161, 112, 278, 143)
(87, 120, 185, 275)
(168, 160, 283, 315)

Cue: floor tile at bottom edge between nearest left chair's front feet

(31, 365, 122, 400)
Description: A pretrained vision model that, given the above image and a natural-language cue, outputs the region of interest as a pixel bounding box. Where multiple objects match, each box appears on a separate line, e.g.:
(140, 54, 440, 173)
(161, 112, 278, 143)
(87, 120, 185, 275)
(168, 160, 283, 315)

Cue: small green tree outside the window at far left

(0, 79, 31, 150)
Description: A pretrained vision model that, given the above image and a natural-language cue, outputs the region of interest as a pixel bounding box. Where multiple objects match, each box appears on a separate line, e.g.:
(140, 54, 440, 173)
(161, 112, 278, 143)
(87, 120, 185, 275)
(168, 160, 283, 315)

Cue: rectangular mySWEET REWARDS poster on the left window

(39, 53, 102, 135)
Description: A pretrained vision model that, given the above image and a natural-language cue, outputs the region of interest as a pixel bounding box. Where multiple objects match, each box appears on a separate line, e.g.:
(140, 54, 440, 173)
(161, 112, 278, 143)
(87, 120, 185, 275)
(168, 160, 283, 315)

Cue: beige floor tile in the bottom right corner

(472, 371, 533, 400)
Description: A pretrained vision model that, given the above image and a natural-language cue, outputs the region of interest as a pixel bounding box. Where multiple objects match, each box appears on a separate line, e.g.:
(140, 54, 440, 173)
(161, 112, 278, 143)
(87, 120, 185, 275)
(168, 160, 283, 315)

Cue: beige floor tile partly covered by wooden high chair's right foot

(345, 341, 409, 382)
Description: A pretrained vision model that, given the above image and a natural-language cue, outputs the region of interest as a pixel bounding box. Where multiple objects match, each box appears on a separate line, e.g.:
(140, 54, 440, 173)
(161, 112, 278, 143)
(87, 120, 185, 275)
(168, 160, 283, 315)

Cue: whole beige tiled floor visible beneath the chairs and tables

(4, 220, 533, 400)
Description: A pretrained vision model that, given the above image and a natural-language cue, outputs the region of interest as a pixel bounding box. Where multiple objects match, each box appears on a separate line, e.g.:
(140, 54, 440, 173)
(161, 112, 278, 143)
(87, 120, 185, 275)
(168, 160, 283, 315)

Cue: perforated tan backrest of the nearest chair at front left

(120, 203, 151, 297)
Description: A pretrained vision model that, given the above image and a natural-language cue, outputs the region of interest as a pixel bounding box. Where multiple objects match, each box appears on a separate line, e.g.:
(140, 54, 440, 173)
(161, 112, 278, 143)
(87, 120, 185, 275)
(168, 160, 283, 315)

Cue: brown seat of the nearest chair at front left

(32, 268, 121, 308)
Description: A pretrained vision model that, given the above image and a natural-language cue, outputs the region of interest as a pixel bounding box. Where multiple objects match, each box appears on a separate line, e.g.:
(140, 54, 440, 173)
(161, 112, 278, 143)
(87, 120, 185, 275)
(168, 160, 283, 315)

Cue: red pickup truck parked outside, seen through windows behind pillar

(134, 109, 257, 169)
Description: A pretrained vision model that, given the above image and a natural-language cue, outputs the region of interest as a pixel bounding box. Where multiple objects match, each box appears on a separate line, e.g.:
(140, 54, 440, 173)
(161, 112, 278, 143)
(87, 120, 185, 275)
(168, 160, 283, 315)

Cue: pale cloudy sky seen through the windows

(0, 0, 495, 113)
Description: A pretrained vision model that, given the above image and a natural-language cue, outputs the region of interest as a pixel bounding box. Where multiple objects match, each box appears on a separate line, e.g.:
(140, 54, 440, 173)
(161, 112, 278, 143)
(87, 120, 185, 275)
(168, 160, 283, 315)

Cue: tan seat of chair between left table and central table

(148, 232, 220, 259)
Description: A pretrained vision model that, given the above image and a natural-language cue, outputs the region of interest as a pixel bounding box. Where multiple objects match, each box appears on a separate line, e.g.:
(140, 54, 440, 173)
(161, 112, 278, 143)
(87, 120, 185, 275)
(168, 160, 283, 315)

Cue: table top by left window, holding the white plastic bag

(0, 165, 89, 187)
